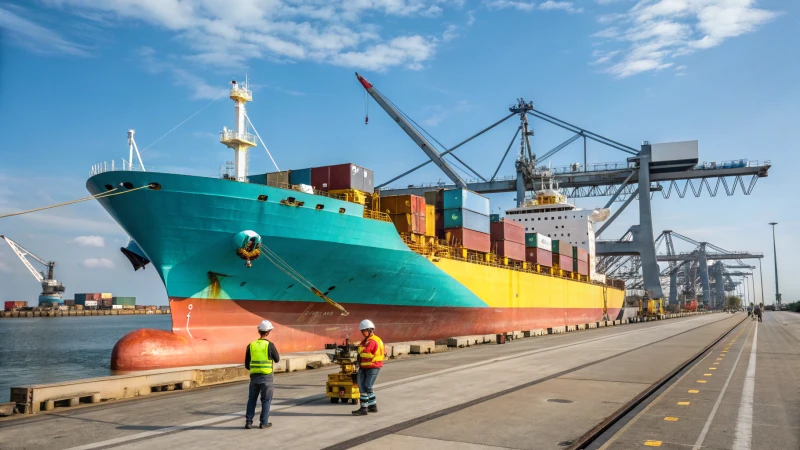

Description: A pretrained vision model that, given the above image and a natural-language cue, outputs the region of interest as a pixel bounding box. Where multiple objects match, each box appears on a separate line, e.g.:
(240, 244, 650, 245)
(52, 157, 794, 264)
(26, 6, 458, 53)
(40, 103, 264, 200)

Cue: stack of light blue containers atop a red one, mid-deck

(437, 189, 492, 252)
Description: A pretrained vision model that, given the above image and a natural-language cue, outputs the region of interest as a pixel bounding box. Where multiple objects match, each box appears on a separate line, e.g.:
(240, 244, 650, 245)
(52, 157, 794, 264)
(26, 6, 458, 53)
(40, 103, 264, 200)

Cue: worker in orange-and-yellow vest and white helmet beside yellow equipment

(353, 320, 386, 416)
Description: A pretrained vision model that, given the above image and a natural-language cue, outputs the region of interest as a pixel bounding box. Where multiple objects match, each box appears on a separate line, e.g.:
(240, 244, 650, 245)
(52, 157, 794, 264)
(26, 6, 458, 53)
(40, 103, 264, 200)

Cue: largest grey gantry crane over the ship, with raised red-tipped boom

(356, 74, 771, 306)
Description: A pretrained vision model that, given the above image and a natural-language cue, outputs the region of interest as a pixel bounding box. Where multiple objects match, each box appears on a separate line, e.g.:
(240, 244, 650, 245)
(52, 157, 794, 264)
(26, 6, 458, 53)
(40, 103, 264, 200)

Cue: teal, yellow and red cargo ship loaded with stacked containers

(87, 78, 624, 371)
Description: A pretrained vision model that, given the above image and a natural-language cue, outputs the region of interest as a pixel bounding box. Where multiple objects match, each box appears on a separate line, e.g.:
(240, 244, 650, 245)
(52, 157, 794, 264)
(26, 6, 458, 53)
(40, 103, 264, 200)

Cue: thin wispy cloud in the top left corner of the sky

(0, 8, 89, 56)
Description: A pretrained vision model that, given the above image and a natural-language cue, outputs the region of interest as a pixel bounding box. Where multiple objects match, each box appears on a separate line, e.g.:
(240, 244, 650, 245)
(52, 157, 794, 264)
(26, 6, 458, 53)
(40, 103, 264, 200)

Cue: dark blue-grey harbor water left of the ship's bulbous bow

(0, 314, 172, 402)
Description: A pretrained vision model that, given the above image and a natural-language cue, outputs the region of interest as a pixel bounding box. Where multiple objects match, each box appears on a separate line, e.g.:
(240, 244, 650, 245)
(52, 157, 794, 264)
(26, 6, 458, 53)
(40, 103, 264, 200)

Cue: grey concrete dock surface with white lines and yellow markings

(0, 312, 800, 450)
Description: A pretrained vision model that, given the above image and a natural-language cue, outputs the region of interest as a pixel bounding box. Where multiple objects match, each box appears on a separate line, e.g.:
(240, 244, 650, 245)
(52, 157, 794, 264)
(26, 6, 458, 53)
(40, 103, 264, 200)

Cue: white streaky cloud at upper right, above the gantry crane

(592, 0, 779, 78)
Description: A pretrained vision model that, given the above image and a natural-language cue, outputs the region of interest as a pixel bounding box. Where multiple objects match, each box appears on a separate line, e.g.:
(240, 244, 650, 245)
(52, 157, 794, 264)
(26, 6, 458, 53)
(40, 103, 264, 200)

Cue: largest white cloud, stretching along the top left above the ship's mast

(42, 0, 463, 73)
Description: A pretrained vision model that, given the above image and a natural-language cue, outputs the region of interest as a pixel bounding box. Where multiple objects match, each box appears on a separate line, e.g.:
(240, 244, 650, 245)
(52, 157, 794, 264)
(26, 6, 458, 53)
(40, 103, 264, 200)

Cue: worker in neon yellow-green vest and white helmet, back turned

(244, 320, 281, 430)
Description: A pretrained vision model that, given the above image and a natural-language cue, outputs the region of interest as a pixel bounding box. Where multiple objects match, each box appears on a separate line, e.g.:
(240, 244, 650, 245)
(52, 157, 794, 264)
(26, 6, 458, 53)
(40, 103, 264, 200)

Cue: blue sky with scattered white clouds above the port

(0, 0, 800, 304)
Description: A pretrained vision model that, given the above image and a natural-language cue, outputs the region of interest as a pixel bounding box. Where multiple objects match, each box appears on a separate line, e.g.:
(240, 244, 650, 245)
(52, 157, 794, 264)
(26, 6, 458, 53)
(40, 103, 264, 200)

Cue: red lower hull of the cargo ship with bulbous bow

(111, 299, 619, 372)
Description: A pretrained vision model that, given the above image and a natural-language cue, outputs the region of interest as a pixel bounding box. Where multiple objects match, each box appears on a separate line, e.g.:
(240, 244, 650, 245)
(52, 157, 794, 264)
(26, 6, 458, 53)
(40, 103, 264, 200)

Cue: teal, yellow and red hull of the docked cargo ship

(87, 171, 624, 371)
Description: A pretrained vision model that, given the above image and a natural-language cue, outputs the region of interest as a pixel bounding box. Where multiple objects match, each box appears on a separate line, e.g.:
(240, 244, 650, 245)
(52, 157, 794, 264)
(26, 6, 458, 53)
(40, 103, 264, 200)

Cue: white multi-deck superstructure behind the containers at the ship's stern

(506, 188, 609, 280)
